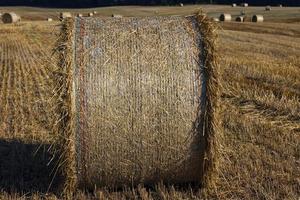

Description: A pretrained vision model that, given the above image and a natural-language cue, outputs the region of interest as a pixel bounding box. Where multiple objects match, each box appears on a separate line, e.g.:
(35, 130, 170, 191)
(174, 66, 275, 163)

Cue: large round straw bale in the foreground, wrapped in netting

(57, 15, 220, 194)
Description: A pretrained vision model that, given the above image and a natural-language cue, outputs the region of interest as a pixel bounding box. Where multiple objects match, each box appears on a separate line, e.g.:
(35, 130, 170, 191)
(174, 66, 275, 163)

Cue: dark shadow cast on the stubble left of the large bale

(0, 140, 59, 194)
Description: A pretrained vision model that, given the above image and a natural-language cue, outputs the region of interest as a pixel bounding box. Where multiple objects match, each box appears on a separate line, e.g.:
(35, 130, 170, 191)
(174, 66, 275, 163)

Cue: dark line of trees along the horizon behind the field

(0, 0, 300, 8)
